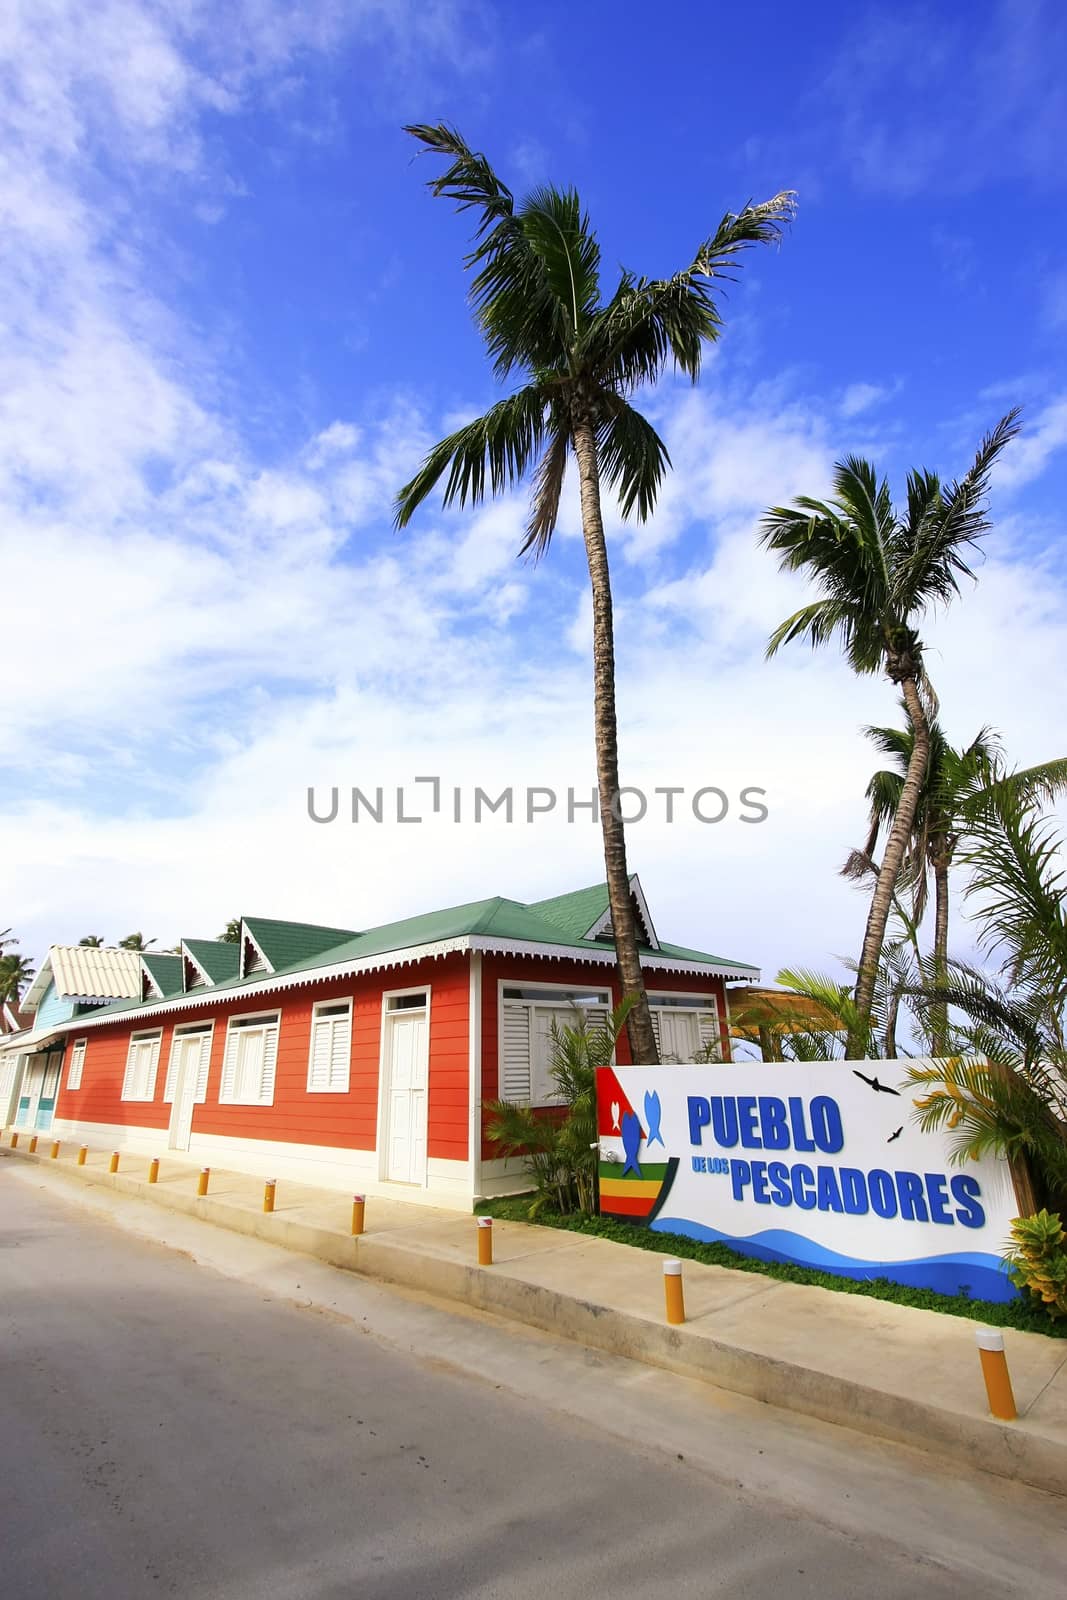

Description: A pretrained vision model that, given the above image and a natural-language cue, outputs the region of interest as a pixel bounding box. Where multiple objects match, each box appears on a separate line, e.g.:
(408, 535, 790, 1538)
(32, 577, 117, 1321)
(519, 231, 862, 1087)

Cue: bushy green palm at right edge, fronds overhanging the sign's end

(910, 781, 1067, 1210)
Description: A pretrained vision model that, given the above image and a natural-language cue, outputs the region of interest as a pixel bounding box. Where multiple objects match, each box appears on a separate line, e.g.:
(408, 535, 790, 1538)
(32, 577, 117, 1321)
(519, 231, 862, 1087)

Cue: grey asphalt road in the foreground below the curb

(0, 1163, 1064, 1600)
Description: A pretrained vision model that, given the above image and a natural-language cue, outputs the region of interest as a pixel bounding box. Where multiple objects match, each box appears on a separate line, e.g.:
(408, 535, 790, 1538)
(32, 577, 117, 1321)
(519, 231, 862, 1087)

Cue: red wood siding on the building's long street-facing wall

(56, 955, 470, 1160)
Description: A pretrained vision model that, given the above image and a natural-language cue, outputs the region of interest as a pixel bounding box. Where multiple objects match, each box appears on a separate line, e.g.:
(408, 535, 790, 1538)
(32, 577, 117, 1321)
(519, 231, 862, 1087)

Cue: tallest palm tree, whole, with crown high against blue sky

(397, 125, 793, 1062)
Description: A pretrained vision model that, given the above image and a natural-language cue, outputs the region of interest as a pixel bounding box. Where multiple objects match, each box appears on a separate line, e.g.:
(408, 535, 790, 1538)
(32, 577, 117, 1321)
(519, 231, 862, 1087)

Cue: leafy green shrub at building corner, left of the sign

(486, 995, 633, 1221)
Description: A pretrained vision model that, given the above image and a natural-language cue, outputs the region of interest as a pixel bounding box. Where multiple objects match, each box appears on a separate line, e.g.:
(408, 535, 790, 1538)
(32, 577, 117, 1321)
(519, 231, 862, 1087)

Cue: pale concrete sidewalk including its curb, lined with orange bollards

(0, 1131, 1067, 1494)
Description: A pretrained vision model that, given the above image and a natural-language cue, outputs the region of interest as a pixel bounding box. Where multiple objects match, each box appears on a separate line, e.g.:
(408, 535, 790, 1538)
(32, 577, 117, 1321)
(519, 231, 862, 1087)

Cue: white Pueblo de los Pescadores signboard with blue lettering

(597, 1061, 1019, 1301)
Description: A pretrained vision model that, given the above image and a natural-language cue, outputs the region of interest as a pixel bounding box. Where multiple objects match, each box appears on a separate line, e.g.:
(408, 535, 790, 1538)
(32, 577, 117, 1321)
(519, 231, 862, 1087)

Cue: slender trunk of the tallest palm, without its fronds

(573, 416, 659, 1066)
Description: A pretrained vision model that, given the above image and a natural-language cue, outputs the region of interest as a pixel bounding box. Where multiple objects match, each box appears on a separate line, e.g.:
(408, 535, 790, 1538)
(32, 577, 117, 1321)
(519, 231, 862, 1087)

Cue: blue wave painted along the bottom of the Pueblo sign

(649, 1216, 1019, 1304)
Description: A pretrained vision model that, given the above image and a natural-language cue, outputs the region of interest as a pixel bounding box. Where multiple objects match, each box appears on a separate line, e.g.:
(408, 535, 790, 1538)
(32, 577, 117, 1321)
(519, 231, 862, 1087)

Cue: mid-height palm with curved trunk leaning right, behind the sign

(761, 411, 1019, 1053)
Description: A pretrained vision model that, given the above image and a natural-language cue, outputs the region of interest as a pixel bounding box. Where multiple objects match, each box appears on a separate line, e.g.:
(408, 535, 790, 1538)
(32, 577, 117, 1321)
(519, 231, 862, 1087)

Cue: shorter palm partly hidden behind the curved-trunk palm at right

(843, 717, 1067, 1056)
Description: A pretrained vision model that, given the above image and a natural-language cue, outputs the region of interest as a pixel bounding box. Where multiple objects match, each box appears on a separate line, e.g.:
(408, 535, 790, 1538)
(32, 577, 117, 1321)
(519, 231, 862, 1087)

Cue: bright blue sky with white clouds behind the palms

(0, 0, 1067, 973)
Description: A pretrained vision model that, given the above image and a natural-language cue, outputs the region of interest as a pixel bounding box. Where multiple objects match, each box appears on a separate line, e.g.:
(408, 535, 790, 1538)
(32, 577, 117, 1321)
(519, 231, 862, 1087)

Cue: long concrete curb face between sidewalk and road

(2, 1149, 1067, 1494)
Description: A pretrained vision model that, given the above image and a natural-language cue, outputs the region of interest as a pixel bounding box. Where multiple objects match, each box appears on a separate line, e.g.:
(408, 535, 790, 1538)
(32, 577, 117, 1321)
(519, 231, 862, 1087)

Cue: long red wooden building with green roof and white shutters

(0, 878, 758, 1208)
